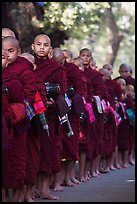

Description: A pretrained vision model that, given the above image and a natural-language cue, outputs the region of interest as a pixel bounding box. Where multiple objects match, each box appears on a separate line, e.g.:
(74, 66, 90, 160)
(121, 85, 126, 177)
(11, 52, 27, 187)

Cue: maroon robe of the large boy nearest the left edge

(2, 57, 41, 184)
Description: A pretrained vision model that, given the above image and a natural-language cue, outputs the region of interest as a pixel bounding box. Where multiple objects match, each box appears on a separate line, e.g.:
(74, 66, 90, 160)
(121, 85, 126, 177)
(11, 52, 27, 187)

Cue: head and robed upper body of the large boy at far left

(2, 37, 37, 107)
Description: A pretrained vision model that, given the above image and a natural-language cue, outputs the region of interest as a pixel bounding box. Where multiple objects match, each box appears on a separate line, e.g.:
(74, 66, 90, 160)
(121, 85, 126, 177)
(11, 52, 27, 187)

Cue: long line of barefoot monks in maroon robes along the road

(2, 28, 135, 202)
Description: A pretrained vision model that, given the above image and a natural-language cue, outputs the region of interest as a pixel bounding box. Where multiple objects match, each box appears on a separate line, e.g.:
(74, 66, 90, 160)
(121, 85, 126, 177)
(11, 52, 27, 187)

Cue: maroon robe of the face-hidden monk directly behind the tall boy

(62, 61, 83, 160)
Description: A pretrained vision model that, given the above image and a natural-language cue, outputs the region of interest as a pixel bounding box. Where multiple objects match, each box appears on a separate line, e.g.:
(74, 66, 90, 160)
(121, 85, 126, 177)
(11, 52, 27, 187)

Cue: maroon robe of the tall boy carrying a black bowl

(34, 56, 67, 174)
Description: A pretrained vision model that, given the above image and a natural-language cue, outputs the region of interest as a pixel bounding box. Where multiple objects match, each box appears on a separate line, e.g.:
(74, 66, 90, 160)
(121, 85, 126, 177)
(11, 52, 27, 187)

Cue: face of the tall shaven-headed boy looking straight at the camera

(32, 35, 51, 58)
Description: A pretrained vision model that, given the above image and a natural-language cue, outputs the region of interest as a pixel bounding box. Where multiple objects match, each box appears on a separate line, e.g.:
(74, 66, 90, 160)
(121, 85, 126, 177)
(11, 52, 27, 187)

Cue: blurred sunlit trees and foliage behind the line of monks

(2, 2, 135, 76)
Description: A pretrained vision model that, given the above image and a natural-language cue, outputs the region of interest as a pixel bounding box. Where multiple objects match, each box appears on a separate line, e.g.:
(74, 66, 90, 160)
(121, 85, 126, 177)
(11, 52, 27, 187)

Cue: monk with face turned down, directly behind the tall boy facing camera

(53, 48, 84, 186)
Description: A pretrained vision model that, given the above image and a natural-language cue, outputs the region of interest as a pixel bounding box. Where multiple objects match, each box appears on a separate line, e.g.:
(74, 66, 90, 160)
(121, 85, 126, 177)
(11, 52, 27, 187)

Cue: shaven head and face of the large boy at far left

(2, 41, 20, 64)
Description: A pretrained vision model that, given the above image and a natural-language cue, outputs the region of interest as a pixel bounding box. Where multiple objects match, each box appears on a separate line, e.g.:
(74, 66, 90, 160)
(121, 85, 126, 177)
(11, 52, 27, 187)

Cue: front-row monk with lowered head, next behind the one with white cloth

(98, 68, 118, 173)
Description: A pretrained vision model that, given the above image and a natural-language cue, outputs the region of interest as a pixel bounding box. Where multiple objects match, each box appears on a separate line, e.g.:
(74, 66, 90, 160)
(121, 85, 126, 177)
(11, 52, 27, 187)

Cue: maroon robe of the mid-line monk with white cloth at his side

(84, 66, 108, 156)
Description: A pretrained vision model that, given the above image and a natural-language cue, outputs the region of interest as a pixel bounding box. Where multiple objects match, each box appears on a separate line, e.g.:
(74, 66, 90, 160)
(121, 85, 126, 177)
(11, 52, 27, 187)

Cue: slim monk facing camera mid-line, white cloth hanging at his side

(79, 48, 108, 176)
